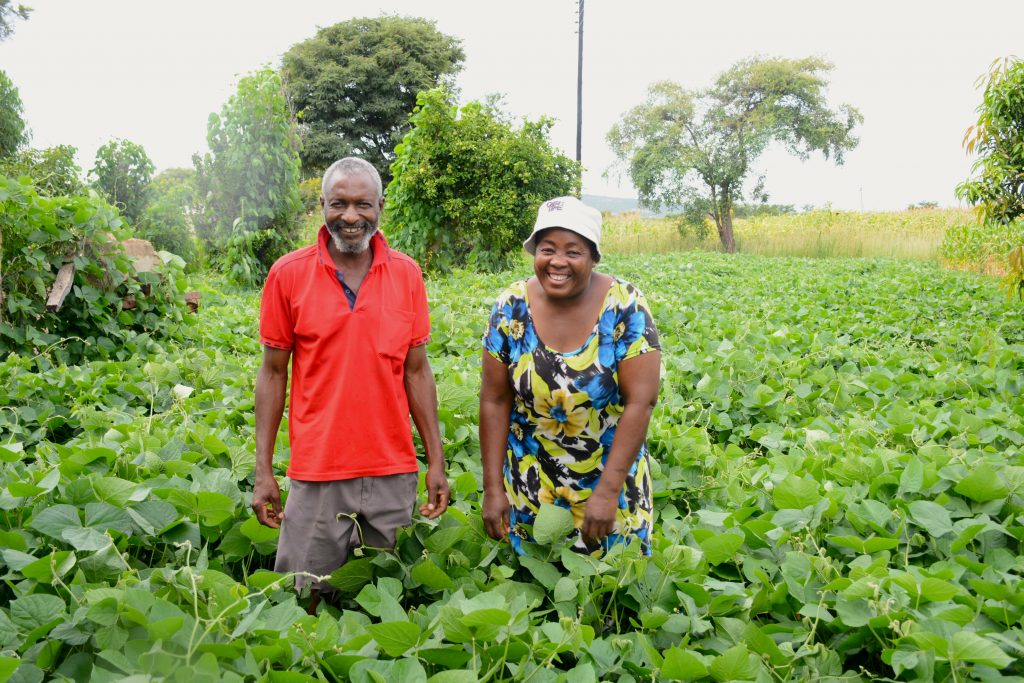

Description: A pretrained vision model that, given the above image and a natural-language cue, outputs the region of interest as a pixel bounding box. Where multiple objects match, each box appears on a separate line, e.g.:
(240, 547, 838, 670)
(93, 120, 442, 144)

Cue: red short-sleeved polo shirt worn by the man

(260, 227, 430, 481)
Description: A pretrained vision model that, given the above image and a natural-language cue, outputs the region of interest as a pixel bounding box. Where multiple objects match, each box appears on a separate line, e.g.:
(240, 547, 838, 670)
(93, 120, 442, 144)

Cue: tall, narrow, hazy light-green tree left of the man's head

(193, 69, 302, 286)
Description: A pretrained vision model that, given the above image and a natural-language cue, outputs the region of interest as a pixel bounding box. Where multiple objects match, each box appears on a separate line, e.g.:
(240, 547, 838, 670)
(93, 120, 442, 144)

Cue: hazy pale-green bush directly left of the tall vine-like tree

(135, 168, 197, 264)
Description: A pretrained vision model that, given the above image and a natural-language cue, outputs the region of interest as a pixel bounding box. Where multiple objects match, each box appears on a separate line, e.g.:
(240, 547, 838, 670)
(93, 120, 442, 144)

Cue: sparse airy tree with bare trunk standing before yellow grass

(608, 58, 863, 252)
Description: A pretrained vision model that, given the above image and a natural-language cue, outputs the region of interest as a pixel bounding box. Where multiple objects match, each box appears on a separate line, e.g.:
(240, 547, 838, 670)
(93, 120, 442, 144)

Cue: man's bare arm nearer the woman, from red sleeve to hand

(404, 344, 451, 519)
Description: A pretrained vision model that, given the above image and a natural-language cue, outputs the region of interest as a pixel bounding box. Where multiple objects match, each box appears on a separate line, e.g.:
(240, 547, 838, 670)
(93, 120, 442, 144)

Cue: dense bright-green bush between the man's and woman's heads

(385, 89, 580, 269)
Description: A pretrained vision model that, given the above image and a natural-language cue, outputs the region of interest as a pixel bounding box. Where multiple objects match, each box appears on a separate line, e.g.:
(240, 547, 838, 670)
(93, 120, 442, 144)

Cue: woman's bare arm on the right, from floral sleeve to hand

(581, 350, 662, 542)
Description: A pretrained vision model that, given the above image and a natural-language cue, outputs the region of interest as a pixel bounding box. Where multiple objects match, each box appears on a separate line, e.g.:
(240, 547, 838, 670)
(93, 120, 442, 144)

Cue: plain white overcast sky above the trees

(0, 0, 1024, 210)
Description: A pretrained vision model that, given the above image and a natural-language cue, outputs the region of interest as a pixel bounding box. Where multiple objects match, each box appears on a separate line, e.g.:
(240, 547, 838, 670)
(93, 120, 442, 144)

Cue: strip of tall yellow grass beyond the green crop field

(601, 209, 974, 260)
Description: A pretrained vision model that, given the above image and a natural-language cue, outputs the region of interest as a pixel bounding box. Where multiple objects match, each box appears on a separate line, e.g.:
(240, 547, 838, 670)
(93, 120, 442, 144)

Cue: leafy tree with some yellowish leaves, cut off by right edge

(956, 57, 1024, 223)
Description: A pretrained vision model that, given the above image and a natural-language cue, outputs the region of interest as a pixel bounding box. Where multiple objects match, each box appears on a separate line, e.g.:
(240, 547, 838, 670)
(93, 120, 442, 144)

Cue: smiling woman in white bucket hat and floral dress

(480, 197, 660, 553)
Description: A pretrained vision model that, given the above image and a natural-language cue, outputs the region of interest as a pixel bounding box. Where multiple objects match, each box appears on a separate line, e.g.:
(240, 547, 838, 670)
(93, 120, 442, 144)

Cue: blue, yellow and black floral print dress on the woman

(483, 279, 659, 553)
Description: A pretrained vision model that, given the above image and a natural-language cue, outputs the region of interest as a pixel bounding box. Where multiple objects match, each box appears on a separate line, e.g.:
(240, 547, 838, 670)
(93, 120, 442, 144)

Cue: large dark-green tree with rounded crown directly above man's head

(282, 16, 465, 184)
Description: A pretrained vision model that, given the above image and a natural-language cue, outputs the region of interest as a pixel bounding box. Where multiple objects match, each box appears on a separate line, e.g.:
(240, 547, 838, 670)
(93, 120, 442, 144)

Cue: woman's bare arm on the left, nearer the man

(480, 350, 513, 539)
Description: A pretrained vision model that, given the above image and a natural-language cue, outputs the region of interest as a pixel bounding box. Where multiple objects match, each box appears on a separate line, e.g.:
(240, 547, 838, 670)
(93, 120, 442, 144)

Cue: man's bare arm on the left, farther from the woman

(252, 346, 292, 528)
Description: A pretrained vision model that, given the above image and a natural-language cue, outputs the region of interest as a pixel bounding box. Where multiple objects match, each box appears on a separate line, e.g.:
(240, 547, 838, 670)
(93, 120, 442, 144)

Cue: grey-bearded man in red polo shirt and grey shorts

(252, 158, 449, 613)
